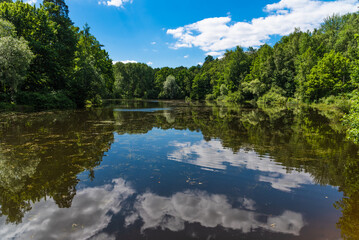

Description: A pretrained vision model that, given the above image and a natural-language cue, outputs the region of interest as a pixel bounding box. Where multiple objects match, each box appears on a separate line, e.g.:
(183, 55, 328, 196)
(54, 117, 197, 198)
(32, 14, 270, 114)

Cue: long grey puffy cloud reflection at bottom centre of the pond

(126, 191, 305, 236)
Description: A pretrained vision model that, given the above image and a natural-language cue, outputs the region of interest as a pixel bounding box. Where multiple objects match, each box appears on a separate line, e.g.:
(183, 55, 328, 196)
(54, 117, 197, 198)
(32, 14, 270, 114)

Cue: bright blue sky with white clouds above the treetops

(30, 0, 359, 67)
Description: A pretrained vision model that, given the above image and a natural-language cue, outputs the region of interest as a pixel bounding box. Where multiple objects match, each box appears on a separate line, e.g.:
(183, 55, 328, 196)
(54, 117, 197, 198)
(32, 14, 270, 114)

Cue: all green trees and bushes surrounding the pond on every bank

(0, 0, 359, 143)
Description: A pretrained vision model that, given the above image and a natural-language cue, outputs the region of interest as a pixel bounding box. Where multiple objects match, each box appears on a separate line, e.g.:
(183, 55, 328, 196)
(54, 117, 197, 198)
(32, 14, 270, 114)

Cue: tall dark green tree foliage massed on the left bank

(0, 0, 114, 108)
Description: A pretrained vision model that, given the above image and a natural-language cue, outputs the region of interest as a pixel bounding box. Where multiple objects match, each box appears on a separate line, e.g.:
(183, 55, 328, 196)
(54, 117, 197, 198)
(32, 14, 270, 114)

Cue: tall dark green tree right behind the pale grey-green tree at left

(0, 1, 65, 91)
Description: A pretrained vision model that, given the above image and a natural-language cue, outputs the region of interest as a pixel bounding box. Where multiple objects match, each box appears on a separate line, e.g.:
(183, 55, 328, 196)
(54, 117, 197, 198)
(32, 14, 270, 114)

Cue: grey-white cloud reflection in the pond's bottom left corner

(0, 179, 135, 240)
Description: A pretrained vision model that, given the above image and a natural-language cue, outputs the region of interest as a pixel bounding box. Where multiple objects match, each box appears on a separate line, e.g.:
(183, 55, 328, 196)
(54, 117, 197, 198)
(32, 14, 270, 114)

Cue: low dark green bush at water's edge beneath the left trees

(16, 92, 75, 110)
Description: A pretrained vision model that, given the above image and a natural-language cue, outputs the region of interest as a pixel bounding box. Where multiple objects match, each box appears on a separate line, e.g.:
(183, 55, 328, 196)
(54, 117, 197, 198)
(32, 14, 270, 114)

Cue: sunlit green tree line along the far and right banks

(114, 13, 359, 104)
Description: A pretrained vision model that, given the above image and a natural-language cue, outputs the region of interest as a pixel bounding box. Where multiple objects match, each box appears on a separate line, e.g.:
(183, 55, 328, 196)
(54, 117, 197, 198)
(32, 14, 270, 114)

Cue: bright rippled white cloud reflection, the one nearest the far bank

(168, 140, 313, 192)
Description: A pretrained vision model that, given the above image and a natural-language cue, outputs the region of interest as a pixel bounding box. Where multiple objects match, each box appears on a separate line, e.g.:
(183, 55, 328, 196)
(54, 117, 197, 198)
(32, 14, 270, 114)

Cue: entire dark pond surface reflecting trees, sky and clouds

(0, 102, 359, 240)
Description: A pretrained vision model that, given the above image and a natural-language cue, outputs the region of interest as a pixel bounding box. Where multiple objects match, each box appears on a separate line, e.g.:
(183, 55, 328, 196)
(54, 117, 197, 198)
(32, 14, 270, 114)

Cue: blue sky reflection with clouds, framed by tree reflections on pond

(0, 103, 354, 239)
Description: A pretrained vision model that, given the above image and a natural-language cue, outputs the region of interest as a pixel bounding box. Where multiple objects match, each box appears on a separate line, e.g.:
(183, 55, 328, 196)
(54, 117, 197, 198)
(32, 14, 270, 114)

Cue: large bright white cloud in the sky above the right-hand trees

(167, 0, 359, 52)
